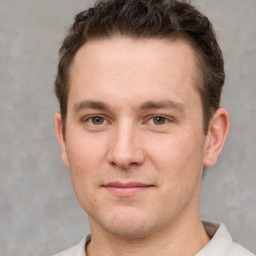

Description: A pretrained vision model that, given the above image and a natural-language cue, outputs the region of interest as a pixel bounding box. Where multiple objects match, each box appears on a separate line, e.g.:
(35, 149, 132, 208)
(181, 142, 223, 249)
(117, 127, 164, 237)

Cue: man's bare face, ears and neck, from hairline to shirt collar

(55, 37, 229, 256)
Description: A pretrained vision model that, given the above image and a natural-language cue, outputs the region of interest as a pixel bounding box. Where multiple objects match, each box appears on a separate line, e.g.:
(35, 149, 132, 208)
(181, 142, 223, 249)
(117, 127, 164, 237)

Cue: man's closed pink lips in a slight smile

(102, 182, 153, 197)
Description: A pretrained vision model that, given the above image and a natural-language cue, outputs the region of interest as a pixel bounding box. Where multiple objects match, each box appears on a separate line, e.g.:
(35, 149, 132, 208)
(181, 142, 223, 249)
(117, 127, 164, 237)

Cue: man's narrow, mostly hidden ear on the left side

(55, 113, 69, 167)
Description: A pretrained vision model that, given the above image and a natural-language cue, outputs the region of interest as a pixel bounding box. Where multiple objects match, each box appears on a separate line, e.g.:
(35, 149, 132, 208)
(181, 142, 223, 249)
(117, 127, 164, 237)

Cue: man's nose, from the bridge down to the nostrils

(108, 123, 145, 170)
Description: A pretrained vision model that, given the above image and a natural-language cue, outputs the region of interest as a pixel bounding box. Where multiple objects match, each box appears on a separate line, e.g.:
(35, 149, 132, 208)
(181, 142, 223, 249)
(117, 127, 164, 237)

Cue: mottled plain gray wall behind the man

(0, 0, 256, 256)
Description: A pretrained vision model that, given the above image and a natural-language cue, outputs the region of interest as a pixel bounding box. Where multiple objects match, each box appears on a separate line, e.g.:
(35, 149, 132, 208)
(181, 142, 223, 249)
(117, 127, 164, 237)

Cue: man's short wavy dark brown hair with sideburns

(55, 0, 225, 133)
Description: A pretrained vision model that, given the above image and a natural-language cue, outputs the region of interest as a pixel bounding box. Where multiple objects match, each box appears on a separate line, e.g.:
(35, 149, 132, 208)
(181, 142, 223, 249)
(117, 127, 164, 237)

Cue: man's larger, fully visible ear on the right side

(203, 108, 229, 167)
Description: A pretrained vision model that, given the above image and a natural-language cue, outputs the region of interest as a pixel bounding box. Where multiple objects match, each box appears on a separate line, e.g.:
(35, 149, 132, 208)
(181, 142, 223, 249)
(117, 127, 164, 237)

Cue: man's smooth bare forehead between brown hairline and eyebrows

(69, 37, 201, 108)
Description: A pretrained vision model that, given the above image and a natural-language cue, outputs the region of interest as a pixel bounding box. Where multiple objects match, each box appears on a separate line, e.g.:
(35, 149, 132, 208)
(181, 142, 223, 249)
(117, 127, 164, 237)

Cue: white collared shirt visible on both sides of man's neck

(54, 221, 255, 256)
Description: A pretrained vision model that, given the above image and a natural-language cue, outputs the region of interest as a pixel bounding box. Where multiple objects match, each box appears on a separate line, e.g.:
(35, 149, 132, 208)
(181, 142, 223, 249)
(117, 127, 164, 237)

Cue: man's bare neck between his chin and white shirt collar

(87, 217, 210, 256)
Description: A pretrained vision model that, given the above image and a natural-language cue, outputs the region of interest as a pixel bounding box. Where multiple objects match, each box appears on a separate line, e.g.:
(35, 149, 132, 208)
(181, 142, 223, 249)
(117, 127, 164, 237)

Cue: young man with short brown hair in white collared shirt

(55, 0, 252, 256)
